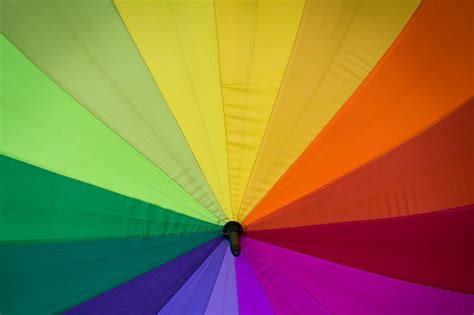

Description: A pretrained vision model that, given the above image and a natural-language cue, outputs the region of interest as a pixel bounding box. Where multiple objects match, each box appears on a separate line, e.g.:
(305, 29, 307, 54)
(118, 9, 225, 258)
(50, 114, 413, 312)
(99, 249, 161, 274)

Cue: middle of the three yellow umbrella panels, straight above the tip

(215, 0, 305, 220)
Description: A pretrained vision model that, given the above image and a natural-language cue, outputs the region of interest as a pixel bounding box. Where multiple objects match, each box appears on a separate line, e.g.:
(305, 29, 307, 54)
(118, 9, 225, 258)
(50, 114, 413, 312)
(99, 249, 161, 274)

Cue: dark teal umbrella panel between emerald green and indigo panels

(0, 232, 217, 315)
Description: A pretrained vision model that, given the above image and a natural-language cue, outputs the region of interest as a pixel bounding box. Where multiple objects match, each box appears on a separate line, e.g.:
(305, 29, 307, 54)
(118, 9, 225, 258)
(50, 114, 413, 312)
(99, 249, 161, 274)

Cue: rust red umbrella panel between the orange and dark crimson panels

(247, 98, 474, 230)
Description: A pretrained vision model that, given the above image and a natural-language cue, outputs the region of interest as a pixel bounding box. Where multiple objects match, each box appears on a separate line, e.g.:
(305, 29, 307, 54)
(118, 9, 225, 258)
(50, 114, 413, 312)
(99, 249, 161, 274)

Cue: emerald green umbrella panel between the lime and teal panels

(0, 155, 220, 242)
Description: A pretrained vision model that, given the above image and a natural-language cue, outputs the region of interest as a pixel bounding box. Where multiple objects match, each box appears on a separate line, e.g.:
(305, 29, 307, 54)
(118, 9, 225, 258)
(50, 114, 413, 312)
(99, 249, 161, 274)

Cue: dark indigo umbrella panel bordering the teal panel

(67, 238, 222, 314)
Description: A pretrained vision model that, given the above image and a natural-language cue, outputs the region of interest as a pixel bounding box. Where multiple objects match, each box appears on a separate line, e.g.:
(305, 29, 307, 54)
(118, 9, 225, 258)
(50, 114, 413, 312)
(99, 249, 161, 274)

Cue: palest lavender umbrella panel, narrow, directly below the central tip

(206, 247, 239, 315)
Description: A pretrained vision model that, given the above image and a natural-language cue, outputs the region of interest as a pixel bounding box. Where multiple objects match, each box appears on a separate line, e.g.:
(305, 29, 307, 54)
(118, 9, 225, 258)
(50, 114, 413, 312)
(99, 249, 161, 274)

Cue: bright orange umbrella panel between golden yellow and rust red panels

(245, 0, 474, 223)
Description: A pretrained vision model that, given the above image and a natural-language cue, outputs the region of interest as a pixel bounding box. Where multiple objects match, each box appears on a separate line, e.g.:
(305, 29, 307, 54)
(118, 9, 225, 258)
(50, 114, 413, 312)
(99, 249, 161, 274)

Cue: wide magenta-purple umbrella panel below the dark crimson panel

(242, 238, 474, 315)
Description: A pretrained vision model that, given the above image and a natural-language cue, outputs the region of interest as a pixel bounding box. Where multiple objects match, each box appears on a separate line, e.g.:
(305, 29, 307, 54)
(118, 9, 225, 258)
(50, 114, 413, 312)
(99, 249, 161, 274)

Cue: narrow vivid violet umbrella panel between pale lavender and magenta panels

(235, 241, 274, 315)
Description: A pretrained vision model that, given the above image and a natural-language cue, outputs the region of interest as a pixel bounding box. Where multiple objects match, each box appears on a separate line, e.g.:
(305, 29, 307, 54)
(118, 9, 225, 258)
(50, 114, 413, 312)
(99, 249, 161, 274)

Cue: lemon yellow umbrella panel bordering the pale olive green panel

(115, 0, 231, 217)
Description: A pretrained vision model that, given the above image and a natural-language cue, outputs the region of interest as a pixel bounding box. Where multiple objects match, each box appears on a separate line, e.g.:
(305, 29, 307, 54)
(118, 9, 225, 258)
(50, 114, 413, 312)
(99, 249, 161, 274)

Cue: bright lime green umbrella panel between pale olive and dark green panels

(0, 35, 219, 222)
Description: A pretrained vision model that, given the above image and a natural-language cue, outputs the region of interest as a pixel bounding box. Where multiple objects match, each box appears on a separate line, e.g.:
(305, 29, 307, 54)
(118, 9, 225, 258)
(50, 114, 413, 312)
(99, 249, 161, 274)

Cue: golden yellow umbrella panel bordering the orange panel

(240, 0, 420, 218)
